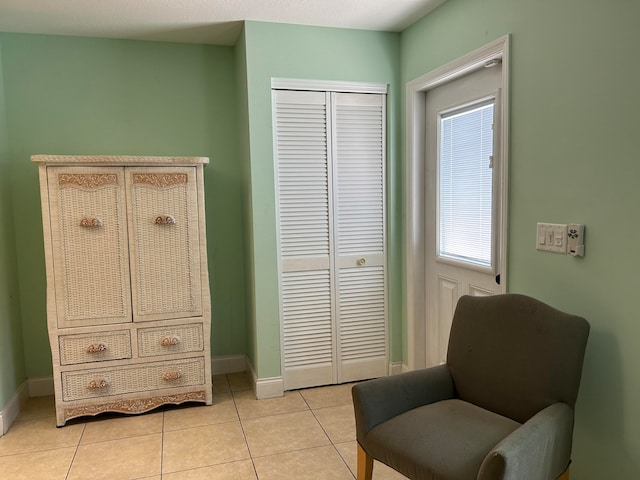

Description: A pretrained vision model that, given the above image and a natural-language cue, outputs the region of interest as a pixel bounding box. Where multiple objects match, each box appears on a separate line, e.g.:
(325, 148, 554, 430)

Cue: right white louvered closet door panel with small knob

(333, 93, 388, 383)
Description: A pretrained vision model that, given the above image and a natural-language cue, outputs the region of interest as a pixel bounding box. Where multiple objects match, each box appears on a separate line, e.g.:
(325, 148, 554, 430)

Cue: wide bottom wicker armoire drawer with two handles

(62, 357, 205, 402)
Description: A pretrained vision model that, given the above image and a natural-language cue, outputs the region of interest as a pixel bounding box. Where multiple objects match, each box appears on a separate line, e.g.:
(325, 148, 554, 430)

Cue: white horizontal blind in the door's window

(438, 99, 495, 267)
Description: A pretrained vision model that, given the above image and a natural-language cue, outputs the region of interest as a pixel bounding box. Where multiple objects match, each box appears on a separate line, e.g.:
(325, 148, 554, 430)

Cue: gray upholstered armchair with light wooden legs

(352, 294, 589, 480)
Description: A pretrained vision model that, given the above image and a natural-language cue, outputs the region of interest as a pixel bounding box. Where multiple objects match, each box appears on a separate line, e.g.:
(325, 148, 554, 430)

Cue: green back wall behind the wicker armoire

(0, 34, 246, 377)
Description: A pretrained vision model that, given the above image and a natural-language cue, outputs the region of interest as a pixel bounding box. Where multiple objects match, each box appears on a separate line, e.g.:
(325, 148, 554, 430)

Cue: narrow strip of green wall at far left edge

(0, 42, 25, 410)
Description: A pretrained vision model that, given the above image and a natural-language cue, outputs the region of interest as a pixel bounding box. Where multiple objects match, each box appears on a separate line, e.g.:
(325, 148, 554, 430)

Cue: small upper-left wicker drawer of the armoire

(58, 330, 131, 365)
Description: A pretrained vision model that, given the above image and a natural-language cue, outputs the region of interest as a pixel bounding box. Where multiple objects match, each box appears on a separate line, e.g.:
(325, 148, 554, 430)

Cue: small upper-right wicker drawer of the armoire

(138, 323, 204, 357)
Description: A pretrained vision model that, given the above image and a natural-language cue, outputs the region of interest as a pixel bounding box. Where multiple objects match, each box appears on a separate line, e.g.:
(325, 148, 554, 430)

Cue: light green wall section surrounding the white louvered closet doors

(243, 22, 402, 378)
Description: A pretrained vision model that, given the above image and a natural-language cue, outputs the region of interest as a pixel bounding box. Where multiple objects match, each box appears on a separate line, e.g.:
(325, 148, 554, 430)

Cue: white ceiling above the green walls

(0, 0, 445, 45)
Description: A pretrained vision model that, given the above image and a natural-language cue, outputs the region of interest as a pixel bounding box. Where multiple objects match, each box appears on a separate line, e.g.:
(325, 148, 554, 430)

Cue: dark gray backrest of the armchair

(447, 294, 589, 423)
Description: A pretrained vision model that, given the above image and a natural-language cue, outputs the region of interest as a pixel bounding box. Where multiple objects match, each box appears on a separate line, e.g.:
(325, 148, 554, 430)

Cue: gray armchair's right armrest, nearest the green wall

(478, 402, 573, 480)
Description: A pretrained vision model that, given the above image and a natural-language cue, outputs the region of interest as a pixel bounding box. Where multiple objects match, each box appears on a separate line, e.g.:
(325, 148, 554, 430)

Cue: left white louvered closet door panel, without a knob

(273, 90, 336, 390)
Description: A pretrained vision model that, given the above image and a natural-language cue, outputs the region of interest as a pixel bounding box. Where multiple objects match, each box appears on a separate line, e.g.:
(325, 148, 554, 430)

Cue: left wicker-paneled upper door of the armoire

(47, 167, 131, 328)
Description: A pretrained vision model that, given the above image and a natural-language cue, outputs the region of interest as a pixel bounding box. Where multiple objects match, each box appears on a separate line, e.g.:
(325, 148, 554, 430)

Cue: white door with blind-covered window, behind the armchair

(425, 63, 506, 366)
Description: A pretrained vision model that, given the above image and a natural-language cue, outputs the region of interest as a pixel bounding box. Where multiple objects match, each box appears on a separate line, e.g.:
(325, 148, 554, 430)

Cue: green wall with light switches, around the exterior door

(402, 0, 640, 480)
